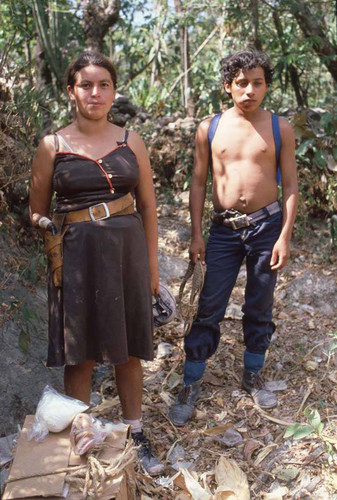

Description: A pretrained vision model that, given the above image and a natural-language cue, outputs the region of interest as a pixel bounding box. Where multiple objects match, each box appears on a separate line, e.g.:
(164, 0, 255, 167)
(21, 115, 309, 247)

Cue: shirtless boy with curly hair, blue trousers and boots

(170, 50, 298, 426)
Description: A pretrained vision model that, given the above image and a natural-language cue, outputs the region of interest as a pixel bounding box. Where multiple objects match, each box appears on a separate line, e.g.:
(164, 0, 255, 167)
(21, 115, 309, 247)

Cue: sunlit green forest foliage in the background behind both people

(0, 0, 337, 221)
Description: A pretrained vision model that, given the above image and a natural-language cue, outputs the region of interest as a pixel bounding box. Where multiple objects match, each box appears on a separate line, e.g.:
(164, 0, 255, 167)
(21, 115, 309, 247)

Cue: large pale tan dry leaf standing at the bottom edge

(214, 456, 250, 500)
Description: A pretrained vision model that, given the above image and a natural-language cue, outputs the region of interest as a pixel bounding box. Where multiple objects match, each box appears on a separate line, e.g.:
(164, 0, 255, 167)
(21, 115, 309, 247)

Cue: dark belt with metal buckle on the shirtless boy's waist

(212, 201, 281, 229)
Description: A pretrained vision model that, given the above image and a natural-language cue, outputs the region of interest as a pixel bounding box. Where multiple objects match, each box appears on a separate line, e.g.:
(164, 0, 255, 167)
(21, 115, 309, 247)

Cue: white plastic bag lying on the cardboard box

(28, 385, 89, 442)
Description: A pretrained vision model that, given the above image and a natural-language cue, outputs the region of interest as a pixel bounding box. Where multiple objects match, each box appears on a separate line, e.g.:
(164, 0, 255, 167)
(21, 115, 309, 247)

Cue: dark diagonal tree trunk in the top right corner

(289, 0, 337, 81)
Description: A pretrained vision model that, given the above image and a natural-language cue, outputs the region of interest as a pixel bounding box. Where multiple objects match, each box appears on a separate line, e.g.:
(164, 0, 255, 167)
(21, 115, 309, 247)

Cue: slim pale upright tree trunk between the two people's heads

(174, 0, 195, 116)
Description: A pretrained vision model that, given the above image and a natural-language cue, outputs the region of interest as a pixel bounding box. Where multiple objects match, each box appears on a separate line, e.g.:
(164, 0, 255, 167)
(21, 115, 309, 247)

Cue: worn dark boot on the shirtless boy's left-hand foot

(169, 380, 201, 427)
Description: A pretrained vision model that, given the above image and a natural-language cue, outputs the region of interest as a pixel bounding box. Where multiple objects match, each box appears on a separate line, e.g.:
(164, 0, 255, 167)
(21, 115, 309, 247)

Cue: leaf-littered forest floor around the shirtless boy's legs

(92, 194, 337, 500)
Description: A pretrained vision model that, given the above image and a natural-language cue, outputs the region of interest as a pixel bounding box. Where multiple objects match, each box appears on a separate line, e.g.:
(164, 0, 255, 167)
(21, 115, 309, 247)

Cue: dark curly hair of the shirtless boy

(220, 49, 274, 85)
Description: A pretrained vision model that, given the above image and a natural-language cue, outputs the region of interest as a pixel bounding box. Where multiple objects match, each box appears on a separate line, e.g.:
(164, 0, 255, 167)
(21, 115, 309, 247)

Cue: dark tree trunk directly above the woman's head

(83, 0, 120, 52)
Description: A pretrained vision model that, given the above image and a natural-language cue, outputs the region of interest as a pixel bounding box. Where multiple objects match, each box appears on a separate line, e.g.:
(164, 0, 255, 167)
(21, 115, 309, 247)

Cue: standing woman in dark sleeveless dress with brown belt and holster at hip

(30, 52, 163, 475)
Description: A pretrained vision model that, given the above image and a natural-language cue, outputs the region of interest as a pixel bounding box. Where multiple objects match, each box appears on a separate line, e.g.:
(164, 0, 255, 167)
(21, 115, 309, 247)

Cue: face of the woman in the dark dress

(67, 64, 116, 120)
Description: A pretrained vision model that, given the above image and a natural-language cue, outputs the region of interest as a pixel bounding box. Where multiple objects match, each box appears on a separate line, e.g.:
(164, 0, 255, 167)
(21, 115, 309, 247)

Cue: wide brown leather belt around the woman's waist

(53, 193, 135, 226)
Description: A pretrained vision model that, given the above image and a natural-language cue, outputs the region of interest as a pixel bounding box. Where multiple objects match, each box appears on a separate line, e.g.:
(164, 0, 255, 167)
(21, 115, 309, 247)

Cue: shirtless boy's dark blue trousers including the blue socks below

(184, 212, 282, 385)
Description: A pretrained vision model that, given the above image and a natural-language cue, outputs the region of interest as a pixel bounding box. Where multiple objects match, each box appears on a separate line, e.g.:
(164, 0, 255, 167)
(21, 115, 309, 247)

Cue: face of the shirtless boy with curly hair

(225, 66, 268, 112)
